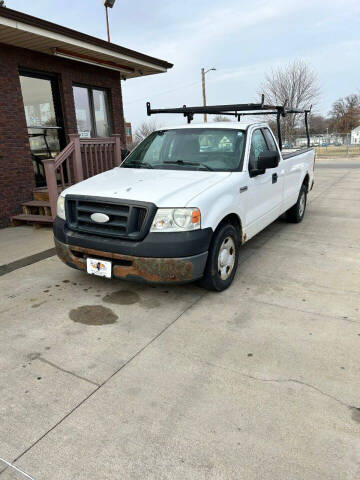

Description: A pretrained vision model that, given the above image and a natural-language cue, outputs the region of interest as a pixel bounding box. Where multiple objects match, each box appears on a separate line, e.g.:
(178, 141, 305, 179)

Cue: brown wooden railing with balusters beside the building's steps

(43, 134, 121, 218)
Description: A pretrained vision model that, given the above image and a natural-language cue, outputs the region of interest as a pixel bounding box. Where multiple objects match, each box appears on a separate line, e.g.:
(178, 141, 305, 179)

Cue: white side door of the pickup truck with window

(240, 127, 284, 238)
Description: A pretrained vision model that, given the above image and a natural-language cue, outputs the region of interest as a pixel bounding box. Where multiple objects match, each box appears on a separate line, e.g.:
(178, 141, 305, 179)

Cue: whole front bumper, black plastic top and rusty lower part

(53, 217, 213, 283)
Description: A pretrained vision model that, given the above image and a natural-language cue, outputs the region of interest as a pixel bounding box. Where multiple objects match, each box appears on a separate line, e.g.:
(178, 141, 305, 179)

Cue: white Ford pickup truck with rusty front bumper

(54, 106, 314, 291)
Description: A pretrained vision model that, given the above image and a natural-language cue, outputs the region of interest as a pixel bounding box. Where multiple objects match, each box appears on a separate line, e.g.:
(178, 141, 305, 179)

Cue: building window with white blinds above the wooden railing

(73, 85, 111, 138)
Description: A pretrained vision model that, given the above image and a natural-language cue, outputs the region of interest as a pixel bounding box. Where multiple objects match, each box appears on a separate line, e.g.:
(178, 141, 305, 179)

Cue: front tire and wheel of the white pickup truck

(199, 223, 240, 292)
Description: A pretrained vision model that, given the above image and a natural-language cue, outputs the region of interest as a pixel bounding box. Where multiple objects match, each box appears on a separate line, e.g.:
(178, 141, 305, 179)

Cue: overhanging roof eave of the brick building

(0, 7, 173, 78)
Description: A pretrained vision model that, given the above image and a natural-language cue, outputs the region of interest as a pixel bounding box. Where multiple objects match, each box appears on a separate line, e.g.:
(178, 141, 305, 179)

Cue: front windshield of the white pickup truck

(121, 128, 245, 171)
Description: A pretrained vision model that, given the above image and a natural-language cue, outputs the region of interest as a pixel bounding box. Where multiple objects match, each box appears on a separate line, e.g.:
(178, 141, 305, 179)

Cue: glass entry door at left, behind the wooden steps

(20, 72, 65, 187)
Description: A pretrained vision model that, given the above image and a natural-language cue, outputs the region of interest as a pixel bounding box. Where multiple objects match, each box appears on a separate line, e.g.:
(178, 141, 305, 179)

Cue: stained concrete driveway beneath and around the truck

(0, 162, 360, 480)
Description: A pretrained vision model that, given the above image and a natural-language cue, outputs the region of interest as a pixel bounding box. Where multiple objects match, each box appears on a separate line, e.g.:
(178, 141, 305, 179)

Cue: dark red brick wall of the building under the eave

(0, 44, 125, 227)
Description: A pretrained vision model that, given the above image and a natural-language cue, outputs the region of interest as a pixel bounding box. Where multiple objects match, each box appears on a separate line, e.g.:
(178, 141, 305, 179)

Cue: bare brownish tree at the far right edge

(329, 94, 360, 133)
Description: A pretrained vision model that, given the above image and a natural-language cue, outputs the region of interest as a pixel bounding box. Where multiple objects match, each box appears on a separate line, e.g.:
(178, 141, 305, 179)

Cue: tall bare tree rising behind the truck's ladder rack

(259, 60, 320, 138)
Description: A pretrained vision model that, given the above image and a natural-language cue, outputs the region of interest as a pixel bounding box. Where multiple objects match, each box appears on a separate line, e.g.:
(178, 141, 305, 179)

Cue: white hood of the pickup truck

(62, 167, 231, 207)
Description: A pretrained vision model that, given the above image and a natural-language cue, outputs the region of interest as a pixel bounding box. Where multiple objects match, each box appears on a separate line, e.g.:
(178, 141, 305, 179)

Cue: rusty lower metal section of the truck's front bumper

(54, 238, 207, 283)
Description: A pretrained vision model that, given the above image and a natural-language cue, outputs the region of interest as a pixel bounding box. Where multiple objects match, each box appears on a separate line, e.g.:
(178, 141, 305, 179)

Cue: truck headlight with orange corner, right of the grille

(150, 208, 201, 232)
